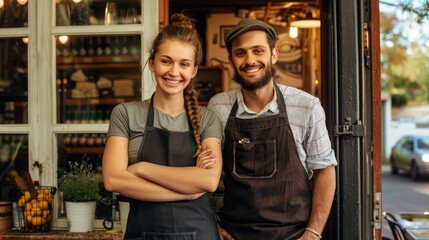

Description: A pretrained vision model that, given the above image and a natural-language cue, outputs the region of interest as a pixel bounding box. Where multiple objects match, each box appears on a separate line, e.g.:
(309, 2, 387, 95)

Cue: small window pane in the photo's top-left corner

(0, 0, 28, 28)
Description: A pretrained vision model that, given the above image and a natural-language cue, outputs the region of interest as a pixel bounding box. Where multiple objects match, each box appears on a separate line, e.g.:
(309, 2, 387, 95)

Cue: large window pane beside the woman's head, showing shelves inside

(56, 35, 141, 124)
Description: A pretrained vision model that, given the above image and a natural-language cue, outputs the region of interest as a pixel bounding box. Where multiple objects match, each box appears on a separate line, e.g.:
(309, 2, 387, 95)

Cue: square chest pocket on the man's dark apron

(232, 140, 277, 178)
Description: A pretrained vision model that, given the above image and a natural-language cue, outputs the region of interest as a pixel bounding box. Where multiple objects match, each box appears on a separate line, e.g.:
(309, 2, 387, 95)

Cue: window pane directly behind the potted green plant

(57, 133, 112, 219)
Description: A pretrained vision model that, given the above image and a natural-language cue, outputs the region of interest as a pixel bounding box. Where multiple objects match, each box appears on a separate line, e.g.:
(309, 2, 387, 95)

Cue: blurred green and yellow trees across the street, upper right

(380, 4, 429, 106)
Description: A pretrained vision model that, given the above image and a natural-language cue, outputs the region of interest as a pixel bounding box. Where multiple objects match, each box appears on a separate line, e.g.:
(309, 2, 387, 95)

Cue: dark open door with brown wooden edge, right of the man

(321, 0, 382, 240)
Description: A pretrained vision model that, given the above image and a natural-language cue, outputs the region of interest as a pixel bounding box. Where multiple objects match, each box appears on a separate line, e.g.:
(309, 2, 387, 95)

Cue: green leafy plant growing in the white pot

(59, 159, 102, 202)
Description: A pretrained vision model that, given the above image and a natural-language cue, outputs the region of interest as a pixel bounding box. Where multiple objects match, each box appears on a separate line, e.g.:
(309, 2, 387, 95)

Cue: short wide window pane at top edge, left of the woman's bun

(55, 0, 141, 26)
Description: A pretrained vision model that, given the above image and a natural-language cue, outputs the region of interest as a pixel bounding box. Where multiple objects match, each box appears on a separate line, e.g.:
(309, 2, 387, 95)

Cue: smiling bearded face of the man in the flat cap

(230, 31, 278, 90)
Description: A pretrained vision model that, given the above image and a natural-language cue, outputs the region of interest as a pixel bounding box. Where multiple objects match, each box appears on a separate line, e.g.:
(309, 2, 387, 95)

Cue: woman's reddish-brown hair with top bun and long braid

(149, 13, 203, 156)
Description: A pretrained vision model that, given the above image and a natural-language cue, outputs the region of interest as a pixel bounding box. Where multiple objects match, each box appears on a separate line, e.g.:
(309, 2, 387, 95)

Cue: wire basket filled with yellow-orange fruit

(17, 187, 56, 232)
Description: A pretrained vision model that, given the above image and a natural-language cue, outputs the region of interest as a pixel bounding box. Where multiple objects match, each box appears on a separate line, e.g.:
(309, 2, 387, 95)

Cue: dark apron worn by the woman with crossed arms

(125, 98, 219, 240)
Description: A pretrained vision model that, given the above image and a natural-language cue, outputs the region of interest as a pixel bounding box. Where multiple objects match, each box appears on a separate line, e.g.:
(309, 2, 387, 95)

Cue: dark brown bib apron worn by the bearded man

(219, 84, 312, 240)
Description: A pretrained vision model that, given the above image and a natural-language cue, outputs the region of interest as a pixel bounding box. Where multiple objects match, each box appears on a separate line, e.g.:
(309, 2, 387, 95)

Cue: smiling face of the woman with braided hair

(149, 40, 197, 97)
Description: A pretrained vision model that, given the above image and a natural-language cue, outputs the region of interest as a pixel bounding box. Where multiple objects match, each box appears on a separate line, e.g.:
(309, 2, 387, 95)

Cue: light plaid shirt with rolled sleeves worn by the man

(208, 84, 337, 178)
